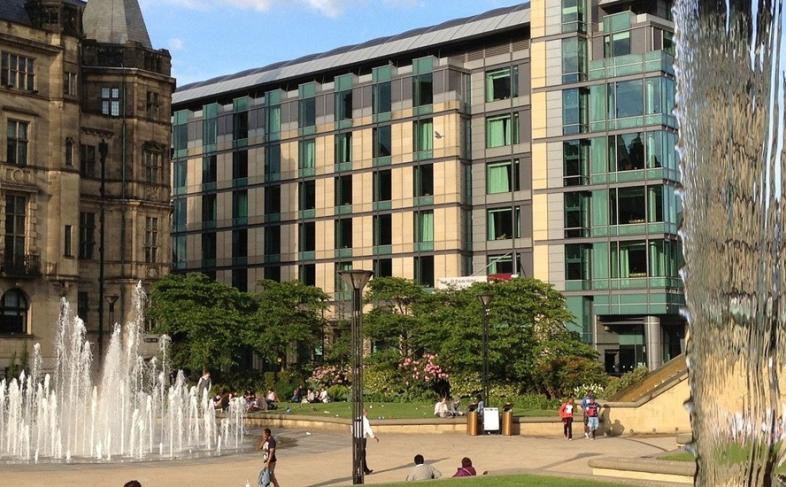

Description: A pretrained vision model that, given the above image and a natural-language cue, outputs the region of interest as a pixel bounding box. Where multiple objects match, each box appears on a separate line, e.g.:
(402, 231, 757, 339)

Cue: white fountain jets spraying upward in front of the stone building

(0, 283, 244, 463)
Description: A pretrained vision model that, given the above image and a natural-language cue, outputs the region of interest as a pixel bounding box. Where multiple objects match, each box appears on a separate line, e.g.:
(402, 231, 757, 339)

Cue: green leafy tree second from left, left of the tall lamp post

(243, 280, 328, 372)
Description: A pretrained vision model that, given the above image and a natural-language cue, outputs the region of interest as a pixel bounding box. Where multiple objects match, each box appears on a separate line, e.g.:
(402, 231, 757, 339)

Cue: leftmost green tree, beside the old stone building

(148, 274, 255, 372)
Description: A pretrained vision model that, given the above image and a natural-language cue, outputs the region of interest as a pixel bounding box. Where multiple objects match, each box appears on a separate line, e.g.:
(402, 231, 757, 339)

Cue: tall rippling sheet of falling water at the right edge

(674, 0, 786, 487)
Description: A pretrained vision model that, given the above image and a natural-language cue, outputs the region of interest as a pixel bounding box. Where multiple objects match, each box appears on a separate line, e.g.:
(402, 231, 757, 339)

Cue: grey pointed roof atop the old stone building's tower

(82, 0, 153, 49)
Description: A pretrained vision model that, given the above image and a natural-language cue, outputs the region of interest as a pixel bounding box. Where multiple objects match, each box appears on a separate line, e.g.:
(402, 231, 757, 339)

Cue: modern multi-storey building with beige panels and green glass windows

(172, 0, 684, 372)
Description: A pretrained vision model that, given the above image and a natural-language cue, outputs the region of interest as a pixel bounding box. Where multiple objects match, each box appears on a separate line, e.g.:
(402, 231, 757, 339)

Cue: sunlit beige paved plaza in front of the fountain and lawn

(0, 430, 677, 487)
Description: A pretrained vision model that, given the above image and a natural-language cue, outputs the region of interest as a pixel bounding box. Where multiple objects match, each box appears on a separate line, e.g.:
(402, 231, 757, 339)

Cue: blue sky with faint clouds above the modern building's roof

(139, 0, 524, 86)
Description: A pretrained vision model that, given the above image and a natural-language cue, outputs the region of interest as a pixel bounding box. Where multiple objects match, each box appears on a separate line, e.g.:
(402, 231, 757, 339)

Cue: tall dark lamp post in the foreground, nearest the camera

(339, 269, 374, 485)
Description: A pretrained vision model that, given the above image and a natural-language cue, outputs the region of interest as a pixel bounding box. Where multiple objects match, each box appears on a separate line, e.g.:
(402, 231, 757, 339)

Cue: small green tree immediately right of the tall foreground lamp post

(363, 277, 426, 359)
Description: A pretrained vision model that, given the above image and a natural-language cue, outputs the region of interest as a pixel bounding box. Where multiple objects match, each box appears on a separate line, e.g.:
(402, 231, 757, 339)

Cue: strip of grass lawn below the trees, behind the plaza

(273, 402, 557, 420)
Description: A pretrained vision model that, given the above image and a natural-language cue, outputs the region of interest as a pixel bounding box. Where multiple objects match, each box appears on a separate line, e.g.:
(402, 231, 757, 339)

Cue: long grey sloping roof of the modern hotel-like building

(175, 0, 530, 104)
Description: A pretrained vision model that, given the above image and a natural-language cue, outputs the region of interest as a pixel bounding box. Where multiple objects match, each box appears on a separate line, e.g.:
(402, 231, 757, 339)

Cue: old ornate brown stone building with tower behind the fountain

(0, 0, 174, 370)
